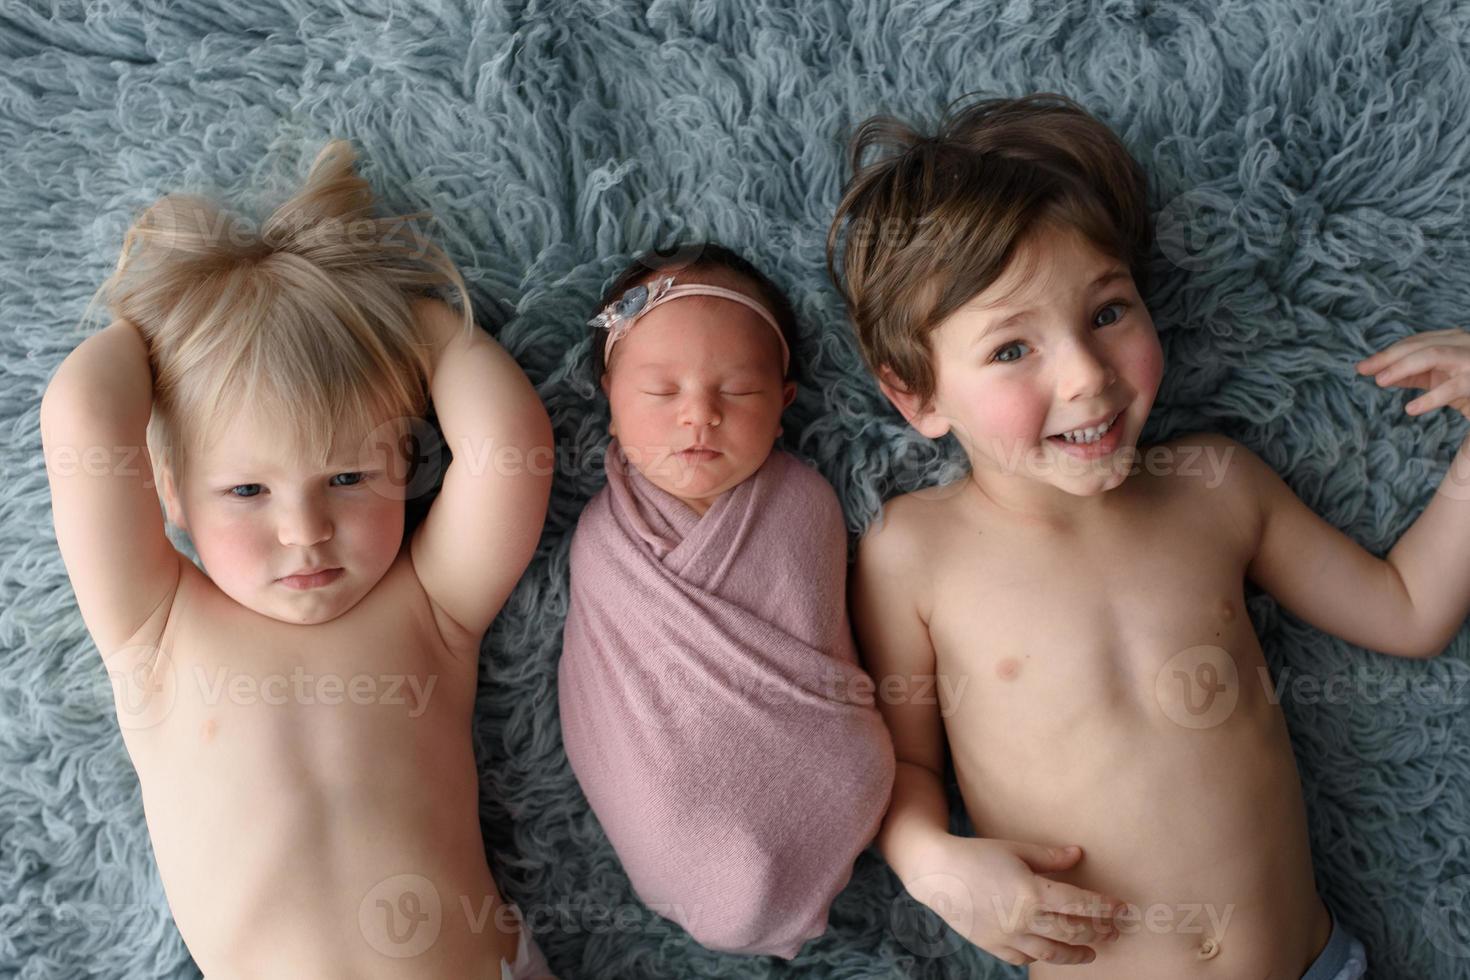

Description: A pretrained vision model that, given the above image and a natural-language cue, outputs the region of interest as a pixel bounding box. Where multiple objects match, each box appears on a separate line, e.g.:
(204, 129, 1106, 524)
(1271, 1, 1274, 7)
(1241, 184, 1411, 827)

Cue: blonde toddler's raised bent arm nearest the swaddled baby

(410, 300, 553, 639)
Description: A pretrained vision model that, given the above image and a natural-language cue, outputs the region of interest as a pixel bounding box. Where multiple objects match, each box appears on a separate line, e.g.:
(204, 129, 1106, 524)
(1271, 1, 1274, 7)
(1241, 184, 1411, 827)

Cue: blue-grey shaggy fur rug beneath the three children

(0, 0, 1470, 980)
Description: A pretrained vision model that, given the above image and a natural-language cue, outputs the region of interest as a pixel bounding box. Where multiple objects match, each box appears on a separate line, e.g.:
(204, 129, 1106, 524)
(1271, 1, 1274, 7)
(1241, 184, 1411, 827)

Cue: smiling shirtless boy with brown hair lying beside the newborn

(829, 96, 1470, 980)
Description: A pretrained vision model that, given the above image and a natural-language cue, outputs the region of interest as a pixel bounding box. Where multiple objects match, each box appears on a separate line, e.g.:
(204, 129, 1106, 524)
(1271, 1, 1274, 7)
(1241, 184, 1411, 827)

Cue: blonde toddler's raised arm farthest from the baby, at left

(41, 320, 182, 655)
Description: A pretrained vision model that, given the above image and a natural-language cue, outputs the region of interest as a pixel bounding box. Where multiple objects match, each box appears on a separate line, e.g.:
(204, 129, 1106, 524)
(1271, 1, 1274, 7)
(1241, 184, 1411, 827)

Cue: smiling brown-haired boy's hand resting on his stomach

(904, 836, 1125, 965)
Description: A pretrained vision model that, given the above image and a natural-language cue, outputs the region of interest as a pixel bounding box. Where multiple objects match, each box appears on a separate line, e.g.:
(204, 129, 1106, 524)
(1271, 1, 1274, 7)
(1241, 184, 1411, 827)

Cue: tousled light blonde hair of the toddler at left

(84, 140, 473, 490)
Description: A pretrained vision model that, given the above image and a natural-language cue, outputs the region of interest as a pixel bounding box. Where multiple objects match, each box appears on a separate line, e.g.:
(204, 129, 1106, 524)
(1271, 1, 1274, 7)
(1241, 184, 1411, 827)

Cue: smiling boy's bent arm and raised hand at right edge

(1222, 331, 1470, 658)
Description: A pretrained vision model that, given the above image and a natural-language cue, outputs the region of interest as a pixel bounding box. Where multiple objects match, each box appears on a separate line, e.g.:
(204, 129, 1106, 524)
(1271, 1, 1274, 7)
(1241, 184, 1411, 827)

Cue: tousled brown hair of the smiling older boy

(828, 93, 1152, 404)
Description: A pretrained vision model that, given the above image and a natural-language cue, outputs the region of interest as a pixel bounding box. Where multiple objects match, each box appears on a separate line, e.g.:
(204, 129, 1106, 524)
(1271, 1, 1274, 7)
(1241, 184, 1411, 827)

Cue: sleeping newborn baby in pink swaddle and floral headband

(560, 245, 894, 959)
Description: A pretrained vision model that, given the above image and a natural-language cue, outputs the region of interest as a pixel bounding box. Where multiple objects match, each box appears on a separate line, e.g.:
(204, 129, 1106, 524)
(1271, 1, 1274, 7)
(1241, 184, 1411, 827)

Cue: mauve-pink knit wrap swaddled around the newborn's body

(559, 441, 894, 959)
